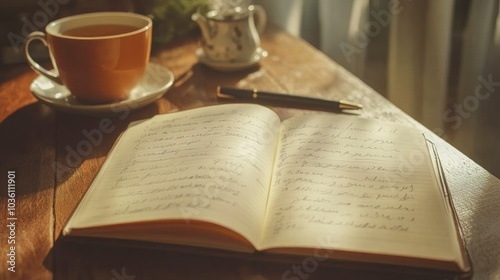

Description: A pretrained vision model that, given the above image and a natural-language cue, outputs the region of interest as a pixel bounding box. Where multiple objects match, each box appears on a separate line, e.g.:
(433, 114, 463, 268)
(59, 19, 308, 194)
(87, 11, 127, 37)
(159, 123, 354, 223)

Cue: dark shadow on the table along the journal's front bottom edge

(46, 238, 462, 280)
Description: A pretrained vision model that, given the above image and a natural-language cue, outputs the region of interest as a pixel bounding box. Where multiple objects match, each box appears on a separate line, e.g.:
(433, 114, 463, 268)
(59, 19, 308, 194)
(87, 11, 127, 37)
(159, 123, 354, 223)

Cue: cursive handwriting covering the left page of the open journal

(73, 105, 279, 244)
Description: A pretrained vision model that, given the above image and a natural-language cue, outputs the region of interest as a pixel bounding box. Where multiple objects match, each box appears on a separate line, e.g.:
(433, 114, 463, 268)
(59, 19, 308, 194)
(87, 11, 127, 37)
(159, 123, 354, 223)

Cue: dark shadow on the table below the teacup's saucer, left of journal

(0, 97, 164, 192)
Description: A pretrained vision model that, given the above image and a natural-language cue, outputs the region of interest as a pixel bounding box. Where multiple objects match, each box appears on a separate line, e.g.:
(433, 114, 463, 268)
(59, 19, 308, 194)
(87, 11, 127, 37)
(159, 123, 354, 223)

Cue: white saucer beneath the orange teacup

(30, 62, 174, 115)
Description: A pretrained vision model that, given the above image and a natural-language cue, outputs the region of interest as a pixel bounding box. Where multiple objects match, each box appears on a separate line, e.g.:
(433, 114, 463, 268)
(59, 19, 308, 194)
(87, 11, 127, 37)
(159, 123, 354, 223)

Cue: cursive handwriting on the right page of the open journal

(265, 117, 446, 248)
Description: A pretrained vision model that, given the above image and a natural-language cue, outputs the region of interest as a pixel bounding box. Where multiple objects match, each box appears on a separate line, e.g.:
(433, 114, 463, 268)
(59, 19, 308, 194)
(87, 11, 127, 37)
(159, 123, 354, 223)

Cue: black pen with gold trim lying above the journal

(217, 86, 363, 110)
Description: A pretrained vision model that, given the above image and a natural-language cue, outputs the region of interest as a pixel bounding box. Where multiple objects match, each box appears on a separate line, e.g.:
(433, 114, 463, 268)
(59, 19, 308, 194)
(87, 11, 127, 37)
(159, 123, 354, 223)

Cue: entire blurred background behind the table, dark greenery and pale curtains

(0, 0, 500, 177)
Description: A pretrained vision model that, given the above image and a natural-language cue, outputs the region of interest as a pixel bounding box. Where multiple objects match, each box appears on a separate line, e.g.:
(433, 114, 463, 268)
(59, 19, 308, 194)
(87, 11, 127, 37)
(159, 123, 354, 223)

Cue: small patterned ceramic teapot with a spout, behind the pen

(191, 5, 267, 63)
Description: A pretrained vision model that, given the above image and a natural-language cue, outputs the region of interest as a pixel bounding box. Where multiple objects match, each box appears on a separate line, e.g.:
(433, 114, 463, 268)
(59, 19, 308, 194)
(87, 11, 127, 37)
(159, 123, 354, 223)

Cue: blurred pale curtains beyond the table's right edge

(256, 0, 500, 177)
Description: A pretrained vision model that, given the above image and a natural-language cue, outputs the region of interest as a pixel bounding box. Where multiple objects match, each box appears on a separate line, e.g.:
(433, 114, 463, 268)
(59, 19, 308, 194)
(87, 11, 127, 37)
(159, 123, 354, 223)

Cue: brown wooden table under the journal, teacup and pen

(0, 25, 500, 279)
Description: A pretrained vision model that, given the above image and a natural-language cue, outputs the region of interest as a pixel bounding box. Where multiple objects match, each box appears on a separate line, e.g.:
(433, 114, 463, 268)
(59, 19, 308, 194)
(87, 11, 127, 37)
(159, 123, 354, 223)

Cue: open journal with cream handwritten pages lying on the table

(63, 104, 469, 272)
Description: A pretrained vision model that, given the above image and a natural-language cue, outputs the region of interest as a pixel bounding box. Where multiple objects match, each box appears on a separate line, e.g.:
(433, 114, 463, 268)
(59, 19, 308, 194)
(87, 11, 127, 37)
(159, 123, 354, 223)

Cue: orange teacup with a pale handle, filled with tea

(25, 12, 153, 103)
